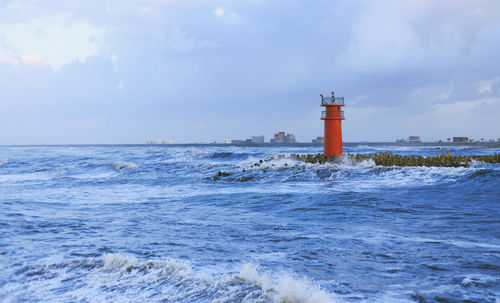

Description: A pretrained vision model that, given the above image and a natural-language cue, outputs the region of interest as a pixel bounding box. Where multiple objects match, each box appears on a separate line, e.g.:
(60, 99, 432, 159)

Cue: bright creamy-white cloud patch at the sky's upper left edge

(0, 15, 104, 71)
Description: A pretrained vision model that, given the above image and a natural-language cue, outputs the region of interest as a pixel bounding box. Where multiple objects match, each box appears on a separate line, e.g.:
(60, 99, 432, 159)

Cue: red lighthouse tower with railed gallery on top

(321, 92, 345, 157)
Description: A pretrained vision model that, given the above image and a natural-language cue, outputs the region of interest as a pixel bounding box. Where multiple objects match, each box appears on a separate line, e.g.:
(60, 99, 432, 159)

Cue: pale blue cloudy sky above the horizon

(0, 0, 500, 144)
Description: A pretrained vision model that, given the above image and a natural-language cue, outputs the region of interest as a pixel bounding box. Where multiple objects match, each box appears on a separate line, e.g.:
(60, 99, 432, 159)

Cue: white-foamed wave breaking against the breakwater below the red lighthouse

(231, 155, 480, 191)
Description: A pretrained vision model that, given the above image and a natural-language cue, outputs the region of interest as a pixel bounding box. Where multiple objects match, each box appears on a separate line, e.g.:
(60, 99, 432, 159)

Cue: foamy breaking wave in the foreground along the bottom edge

(5, 253, 333, 303)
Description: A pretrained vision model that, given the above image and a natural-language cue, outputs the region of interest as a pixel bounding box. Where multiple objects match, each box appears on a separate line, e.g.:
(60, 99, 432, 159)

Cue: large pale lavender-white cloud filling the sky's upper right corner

(336, 0, 498, 72)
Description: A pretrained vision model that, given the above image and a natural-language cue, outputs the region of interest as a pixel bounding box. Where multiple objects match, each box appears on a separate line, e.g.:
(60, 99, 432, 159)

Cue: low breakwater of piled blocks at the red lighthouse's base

(291, 152, 500, 167)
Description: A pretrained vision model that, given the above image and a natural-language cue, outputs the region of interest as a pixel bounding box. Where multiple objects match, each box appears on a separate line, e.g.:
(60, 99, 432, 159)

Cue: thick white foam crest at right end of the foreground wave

(236, 263, 334, 303)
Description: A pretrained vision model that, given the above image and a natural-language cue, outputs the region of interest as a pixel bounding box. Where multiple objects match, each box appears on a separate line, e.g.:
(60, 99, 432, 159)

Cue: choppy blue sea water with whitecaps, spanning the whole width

(0, 146, 500, 303)
